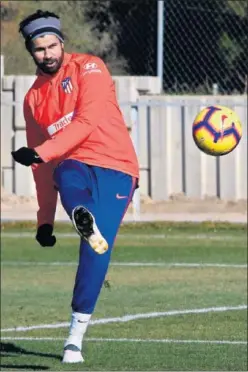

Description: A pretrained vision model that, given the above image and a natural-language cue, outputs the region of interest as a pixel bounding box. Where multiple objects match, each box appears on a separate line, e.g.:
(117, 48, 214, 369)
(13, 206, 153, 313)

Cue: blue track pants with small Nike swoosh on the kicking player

(54, 159, 136, 314)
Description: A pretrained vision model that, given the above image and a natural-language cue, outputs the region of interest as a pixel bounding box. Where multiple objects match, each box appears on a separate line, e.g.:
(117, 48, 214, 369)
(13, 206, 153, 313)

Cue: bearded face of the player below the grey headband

(31, 35, 64, 74)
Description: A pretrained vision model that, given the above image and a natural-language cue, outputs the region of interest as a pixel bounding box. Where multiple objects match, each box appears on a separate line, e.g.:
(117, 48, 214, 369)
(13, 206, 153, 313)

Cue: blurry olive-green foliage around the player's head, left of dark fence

(1, 0, 126, 74)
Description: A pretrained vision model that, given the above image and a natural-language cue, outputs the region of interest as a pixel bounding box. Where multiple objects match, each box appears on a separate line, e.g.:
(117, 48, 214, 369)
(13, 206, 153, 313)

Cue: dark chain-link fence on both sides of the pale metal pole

(85, 0, 248, 94)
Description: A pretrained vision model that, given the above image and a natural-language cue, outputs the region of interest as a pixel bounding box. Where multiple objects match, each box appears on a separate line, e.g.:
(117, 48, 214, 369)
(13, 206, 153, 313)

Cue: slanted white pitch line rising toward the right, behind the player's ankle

(1, 305, 247, 332)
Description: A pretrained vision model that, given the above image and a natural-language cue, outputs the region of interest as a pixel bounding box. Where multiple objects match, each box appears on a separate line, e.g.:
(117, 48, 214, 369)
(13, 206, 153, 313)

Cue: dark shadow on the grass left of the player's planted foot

(0, 342, 61, 371)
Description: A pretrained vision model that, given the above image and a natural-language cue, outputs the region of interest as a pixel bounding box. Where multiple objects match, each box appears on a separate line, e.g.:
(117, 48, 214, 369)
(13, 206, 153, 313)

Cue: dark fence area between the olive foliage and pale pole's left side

(88, 0, 157, 76)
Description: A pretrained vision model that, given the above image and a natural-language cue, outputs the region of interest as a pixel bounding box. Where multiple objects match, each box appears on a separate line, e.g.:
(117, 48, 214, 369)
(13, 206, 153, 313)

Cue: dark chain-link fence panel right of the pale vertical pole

(163, 0, 248, 94)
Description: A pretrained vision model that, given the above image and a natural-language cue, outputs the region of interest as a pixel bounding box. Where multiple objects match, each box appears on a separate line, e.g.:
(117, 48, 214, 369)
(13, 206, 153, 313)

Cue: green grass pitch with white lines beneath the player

(1, 223, 247, 371)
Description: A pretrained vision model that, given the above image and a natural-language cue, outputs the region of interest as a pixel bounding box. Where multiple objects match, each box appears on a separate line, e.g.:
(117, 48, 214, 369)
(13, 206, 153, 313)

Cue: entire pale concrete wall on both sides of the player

(1, 54, 247, 200)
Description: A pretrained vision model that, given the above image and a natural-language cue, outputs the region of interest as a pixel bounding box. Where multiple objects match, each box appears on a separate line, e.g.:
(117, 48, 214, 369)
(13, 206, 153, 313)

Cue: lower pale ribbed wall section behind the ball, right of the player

(139, 95, 247, 200)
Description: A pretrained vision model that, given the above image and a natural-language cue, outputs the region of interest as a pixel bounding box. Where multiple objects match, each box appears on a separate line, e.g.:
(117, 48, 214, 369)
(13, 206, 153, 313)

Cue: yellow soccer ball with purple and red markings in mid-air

(193, 106, 242, 156)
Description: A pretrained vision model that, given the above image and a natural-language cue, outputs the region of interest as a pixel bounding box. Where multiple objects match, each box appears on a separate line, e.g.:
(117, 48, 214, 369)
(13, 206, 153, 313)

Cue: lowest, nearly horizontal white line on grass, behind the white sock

(1, 337, 247, 345)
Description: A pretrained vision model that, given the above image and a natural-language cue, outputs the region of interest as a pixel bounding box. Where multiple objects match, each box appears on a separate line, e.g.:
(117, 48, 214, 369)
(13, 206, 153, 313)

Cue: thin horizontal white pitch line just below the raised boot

(1, 261, 247, 269)
